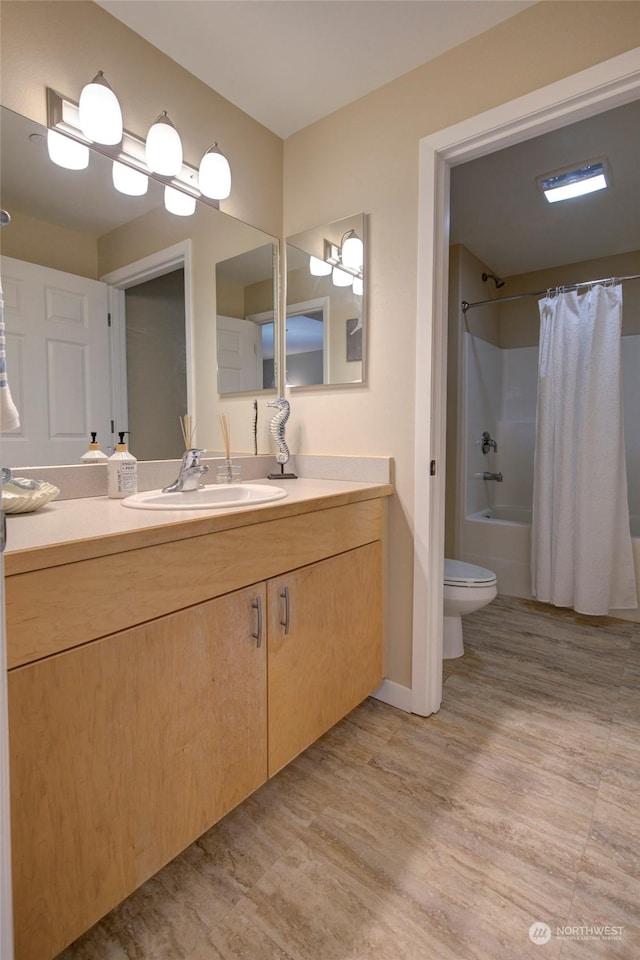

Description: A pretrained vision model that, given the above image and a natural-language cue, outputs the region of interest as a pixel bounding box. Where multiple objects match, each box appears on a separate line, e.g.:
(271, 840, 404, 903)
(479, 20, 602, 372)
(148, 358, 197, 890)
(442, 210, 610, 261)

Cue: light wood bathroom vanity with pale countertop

(6, 481, 392, 960)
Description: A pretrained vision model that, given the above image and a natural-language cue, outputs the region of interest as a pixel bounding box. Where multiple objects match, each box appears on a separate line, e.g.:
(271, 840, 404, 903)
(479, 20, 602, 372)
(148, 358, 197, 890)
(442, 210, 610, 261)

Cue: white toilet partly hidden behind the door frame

(443, 559, 498, 660)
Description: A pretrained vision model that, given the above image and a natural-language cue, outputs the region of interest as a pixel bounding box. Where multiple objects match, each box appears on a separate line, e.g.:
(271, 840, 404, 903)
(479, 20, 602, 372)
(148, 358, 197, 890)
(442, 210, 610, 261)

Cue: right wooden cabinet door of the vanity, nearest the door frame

(267, 542, 383, 776)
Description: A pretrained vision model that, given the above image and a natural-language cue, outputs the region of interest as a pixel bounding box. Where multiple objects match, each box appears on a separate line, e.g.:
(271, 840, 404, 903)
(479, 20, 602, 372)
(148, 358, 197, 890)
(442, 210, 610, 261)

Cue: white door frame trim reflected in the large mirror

(100, 240, 197, 438)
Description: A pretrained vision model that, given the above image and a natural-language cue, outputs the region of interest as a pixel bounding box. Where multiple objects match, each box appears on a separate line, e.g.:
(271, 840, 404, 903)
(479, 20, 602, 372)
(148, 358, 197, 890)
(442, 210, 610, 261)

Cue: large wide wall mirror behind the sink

(0, 107, 279, 466)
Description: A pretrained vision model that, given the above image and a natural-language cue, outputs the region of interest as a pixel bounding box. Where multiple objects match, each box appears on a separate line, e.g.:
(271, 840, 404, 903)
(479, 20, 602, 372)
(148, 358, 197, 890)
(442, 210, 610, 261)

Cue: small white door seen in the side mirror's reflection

(216, 315, 262, 393)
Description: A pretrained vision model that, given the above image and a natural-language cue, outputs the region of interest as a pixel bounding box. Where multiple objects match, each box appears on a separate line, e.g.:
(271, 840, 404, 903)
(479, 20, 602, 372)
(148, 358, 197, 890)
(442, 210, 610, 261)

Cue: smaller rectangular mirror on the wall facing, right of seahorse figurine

(285, 213, 366, 388)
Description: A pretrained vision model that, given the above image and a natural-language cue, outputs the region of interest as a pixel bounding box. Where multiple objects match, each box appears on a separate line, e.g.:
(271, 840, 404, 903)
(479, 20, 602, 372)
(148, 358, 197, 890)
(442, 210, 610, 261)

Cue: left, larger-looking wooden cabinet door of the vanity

(9, 585, 267, 960)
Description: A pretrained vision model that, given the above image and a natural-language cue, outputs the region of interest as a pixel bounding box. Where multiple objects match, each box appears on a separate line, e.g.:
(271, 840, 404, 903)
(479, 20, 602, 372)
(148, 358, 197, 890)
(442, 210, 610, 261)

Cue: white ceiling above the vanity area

(97, 0, 535, 137)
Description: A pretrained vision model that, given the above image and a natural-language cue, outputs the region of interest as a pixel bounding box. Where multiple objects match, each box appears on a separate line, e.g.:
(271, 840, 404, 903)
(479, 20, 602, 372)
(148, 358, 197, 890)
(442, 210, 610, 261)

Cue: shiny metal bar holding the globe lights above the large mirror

(47, 87, 220, 210)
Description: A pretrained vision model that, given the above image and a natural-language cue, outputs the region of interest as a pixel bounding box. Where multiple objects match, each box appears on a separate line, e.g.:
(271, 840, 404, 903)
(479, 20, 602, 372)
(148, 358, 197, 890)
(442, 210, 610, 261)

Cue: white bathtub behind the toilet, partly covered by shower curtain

(460, 507, 640, 623)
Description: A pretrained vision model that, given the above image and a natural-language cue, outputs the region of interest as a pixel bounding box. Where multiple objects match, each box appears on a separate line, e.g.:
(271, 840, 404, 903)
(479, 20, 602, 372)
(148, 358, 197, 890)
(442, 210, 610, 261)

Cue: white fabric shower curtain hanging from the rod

(531, 284, 638, 614)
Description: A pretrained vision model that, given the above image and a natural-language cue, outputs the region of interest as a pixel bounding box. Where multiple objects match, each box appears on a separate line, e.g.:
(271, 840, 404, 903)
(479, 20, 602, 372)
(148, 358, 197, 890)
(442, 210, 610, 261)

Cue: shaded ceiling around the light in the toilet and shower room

(451, 100, 640, 282)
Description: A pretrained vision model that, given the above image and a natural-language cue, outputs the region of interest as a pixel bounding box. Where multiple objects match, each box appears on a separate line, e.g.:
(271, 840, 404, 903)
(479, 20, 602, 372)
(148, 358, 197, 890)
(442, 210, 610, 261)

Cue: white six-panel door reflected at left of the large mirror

(0, 257, 112, 466)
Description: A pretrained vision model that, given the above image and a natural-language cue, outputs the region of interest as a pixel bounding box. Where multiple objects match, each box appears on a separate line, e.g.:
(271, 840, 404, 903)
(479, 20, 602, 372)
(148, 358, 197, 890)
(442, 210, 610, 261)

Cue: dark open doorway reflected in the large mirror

(124, 268, 188, 460)
